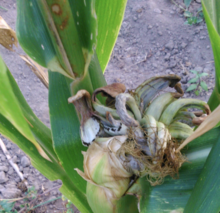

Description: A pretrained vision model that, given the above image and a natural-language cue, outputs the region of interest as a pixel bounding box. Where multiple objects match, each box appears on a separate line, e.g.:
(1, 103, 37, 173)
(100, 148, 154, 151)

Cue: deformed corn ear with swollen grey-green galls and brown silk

(69, 75, 210, 212)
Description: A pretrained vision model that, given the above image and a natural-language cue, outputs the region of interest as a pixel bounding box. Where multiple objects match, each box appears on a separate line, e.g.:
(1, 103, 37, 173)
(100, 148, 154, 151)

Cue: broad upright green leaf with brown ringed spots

(17, 0, 97, 80)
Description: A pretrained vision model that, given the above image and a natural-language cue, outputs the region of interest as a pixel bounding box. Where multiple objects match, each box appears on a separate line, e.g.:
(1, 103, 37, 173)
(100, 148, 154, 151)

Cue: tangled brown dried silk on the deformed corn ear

(117, 128, 186, 186)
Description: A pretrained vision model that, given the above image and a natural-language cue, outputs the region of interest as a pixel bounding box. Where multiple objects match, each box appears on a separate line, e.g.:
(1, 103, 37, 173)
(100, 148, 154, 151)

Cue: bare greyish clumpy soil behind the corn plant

(0, 0, 215, 213)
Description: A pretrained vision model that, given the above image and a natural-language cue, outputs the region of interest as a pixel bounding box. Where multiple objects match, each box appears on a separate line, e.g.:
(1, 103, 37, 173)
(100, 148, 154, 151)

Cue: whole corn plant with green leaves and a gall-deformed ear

(0, 0, 220, 213)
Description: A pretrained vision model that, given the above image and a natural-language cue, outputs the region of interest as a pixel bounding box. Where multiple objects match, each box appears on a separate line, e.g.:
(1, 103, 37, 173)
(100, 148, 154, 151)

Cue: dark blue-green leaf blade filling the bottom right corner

(184, 138, 220, 213)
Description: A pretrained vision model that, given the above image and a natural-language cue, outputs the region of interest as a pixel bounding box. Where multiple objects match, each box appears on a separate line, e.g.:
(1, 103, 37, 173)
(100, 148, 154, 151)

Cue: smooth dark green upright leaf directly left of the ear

(49, 72, 86, 193)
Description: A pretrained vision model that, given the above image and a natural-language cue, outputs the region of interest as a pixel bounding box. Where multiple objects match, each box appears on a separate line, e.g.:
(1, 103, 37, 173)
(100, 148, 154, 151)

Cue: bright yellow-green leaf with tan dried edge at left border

(0, 57, 51, 161)
